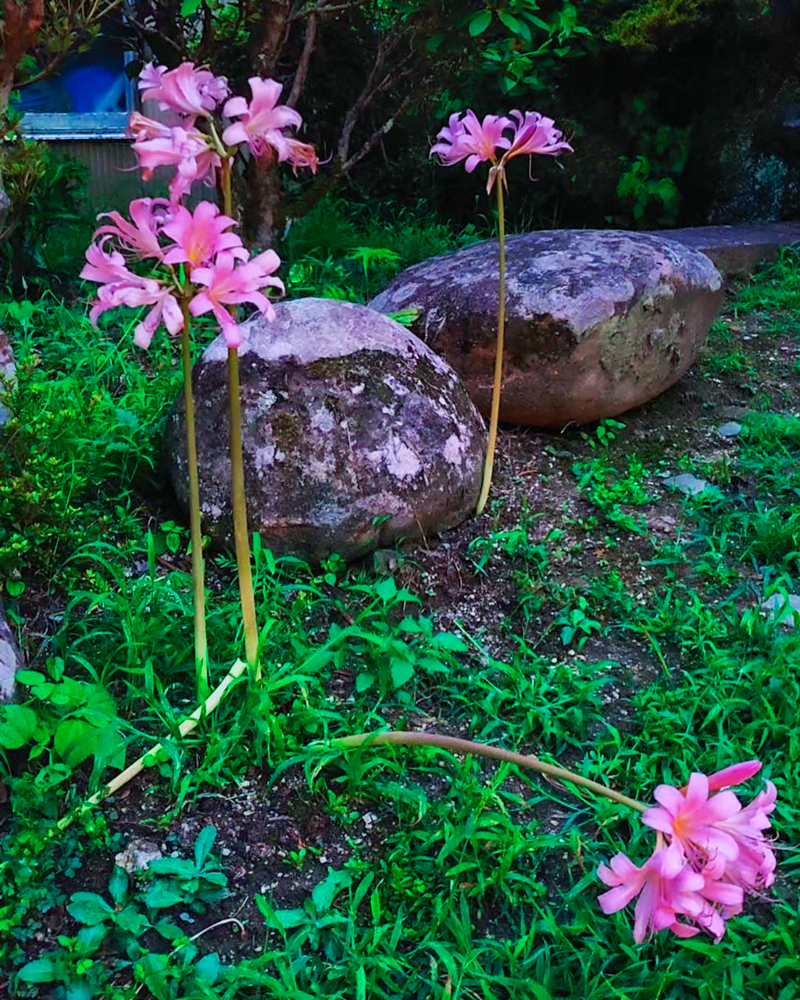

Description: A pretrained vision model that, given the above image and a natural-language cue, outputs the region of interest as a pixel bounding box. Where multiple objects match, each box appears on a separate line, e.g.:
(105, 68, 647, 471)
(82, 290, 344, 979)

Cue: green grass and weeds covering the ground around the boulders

(0, 233, 800, 1000)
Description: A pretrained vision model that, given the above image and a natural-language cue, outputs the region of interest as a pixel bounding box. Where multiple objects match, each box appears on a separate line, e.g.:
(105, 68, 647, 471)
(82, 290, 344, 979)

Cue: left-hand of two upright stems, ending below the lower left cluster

(181, 298, 210, 699)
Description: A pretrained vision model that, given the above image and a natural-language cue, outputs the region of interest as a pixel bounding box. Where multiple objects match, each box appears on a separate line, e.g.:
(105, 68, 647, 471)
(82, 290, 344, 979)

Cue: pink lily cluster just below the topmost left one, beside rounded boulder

(81, 198, 284, 348)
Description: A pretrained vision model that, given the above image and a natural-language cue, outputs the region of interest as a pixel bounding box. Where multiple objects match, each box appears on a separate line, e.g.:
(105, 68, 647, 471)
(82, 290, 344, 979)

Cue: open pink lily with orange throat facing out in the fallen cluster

(642, 774, 742, 863)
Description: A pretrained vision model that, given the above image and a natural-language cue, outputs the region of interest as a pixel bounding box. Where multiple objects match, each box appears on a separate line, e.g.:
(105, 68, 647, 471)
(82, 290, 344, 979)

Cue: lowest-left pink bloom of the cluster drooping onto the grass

(597, 843, 706, 944)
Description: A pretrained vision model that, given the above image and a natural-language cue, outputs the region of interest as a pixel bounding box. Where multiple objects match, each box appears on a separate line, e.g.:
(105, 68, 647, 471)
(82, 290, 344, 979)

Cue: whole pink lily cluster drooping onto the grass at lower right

(597, 760, 776, 942)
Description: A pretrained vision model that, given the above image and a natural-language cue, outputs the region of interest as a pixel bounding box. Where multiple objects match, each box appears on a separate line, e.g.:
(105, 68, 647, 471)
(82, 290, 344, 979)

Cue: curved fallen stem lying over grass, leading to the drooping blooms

(333, 730, 648, 812)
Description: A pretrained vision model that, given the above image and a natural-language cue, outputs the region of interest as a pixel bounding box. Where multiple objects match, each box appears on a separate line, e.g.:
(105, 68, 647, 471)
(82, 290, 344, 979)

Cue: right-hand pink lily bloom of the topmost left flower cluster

(222, 76, 303, 161)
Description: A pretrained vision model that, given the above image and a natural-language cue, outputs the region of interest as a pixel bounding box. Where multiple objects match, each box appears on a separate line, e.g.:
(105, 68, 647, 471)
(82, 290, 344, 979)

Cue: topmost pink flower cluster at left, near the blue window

(128, 63, 319, 201)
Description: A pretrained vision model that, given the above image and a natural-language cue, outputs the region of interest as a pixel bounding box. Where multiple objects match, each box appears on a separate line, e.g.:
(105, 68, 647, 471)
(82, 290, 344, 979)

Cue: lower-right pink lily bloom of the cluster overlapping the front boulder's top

(189, 250, 284, 348)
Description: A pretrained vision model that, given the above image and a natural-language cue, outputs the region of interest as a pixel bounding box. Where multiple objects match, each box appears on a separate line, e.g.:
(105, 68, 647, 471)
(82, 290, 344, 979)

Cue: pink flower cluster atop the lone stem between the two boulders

(431, 111, 573, 193)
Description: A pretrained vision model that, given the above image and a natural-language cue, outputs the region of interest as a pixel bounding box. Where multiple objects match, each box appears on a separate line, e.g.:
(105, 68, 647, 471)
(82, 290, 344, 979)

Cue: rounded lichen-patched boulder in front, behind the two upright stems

(166, 299, 486, 560)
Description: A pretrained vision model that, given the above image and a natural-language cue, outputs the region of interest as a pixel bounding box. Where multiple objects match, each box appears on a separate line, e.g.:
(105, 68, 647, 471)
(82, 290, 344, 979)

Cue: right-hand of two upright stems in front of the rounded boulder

(228, 347, 261, 680)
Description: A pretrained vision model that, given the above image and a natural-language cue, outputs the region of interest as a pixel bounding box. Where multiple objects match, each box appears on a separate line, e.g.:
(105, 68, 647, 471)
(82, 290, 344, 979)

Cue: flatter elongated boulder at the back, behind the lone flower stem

(370, 230, 722, 427)
